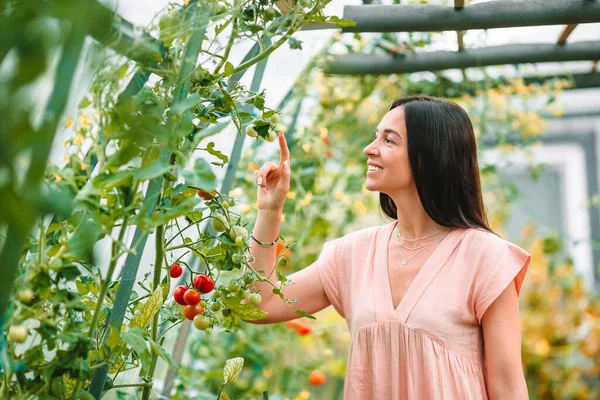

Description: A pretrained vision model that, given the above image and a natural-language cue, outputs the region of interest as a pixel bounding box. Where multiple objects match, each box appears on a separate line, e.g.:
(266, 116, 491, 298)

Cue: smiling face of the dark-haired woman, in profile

(363, 107, 414, 197)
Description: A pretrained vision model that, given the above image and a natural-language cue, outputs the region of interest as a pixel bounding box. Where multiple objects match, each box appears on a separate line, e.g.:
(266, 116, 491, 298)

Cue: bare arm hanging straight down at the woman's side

(481, 281, 529, 400)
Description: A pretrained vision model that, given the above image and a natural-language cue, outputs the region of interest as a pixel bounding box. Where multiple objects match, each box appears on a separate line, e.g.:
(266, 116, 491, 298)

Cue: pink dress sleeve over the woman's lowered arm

(474, 233, 531, 324)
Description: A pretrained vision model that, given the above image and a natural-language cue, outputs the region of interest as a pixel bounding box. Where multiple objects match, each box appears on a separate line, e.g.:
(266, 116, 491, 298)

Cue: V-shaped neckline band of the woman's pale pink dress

(376, 221, 467, 323)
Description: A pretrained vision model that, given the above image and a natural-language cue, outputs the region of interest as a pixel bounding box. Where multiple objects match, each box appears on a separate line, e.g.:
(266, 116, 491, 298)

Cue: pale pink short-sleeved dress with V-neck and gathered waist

(313, 221, 531, 400)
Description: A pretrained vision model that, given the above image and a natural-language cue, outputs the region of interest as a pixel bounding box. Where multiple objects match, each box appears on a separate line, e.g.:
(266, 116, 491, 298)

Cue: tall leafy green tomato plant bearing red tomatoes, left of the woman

(0, 0, 356, 399)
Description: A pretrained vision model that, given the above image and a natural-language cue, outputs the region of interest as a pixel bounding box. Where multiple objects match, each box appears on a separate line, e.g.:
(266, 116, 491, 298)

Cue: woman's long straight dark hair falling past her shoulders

(379, 96, 493, 233)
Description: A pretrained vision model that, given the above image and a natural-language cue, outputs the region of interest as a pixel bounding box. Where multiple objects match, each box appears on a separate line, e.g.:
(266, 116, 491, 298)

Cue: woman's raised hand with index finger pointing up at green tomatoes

(254, 132, 290, 211)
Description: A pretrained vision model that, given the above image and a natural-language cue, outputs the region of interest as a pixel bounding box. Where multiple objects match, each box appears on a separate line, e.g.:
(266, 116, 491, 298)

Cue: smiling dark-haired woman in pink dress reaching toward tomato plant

(251, 96, 531, 400)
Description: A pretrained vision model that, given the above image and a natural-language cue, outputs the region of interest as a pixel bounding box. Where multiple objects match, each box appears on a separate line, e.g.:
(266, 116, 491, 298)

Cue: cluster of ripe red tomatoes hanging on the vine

(170, 264, 215, 330)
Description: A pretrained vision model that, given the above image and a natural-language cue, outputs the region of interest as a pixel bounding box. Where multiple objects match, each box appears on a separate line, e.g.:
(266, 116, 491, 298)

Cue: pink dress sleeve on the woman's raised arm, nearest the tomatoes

(315, 239, 344, 317)
